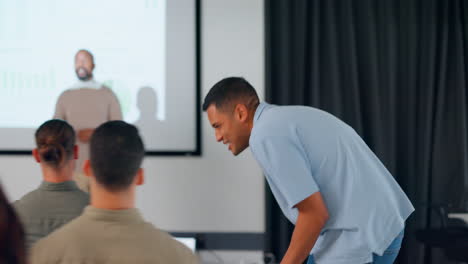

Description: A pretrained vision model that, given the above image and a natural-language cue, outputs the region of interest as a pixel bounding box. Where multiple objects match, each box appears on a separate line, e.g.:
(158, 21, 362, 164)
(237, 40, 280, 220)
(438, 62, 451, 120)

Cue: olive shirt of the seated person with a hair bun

(13, 181, 89, 248)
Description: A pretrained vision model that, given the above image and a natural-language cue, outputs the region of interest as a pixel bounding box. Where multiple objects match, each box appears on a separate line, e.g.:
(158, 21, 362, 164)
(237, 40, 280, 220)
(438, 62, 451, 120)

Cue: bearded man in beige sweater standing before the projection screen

(54, 49, 122, 191)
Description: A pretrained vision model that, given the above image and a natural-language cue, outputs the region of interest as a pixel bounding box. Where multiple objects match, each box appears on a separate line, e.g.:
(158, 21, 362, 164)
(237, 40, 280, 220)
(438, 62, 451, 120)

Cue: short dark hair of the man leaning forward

(203, 77, 260, 111)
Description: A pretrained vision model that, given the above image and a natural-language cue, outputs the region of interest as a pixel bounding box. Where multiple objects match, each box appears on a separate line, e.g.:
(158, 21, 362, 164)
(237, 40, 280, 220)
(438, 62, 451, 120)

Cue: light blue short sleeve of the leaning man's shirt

(251, 136, 319, 208)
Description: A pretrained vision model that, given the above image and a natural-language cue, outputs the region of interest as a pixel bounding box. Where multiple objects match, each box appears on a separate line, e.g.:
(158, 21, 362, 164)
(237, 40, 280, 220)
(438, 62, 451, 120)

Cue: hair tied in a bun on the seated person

(35, 119, 76, 168)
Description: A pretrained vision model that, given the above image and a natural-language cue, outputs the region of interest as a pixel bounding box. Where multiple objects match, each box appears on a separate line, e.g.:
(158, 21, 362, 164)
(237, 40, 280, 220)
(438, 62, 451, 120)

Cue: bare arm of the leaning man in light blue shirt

(281, 192, 328, 264)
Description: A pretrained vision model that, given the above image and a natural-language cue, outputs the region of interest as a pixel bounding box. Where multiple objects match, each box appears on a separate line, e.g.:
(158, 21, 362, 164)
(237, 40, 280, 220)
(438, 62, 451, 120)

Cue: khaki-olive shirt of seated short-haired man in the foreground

(30, 206, 199, 264)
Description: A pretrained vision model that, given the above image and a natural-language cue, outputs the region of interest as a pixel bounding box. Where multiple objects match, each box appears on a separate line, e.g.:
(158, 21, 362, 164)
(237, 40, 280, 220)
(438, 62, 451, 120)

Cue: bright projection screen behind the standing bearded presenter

(0, 0, 196, 151)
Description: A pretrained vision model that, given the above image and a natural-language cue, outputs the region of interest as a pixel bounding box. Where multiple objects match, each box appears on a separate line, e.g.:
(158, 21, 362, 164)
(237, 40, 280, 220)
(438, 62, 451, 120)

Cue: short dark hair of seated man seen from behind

(90, 121, 145, 191)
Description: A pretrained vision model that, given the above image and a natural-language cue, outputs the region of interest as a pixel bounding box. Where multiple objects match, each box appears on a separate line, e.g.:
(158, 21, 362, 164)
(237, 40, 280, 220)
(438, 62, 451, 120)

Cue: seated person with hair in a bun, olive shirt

(14, 119, 89, 248)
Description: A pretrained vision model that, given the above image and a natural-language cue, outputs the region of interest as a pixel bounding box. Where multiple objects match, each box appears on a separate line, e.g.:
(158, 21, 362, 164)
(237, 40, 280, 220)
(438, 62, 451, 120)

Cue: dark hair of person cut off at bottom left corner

(0, 186, 26, 264)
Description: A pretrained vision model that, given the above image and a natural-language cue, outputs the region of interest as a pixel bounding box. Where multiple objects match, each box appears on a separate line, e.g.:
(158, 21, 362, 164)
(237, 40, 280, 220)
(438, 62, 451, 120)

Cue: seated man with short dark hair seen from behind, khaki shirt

(31, 121, 198, 264)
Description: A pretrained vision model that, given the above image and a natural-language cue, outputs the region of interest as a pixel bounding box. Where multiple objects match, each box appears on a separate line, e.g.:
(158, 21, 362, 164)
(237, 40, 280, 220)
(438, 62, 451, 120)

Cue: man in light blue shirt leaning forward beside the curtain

(203, 77, 414, 264)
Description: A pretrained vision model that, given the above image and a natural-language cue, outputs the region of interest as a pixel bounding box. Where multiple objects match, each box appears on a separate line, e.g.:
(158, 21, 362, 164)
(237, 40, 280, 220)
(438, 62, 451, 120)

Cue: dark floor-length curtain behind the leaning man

(265, 0, 468, 264)
